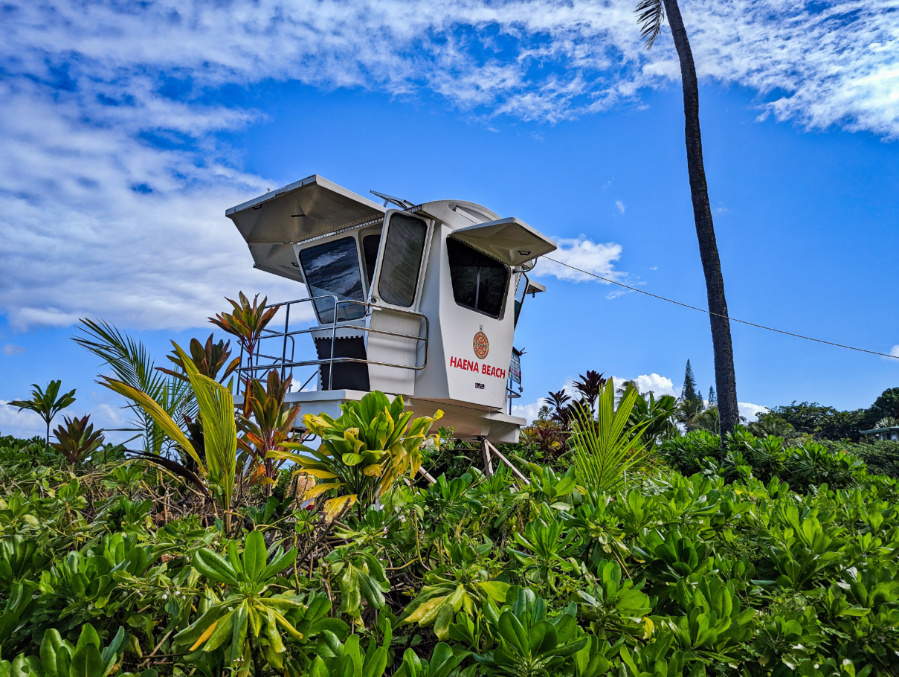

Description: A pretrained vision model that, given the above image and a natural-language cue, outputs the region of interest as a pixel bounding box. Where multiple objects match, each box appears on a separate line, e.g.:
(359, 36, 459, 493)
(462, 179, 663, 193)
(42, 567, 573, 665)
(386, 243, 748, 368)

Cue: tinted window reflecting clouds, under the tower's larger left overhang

(300, 237, 365, 323)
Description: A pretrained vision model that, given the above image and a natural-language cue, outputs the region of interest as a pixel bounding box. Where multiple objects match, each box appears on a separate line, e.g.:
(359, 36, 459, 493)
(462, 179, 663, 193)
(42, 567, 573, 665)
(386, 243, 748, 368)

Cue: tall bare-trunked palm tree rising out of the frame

(637, 0, 740, 440)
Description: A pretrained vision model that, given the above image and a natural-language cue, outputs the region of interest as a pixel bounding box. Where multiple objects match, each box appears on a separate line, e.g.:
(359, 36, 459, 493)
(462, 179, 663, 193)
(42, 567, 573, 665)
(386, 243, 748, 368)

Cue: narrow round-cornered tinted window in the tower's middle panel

(378, 213, 428, 308)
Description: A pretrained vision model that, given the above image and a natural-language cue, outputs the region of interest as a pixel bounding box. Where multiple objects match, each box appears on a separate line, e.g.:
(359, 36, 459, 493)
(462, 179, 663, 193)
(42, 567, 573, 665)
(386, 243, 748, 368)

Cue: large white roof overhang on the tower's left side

(225, 174, 385, 282)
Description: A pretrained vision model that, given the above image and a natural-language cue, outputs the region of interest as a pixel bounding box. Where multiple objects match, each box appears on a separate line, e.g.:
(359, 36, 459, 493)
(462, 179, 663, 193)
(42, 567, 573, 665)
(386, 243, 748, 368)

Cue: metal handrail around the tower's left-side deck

(237, 294, 430, 390)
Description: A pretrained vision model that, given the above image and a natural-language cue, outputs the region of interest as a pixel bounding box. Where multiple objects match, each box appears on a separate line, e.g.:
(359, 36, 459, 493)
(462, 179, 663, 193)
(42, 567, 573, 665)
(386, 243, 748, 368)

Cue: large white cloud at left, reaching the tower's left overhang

(0, 80, 297, 330)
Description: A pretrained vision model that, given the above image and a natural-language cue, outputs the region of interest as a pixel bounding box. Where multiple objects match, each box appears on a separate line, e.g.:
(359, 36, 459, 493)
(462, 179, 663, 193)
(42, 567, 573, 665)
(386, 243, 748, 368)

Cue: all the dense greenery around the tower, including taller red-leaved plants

(0, 298, 899, 677)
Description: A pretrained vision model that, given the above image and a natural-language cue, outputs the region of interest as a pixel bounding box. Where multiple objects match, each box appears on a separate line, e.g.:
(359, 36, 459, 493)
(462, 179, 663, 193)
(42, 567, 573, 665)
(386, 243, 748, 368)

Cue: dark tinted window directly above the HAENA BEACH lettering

(446, 237, 509, 317)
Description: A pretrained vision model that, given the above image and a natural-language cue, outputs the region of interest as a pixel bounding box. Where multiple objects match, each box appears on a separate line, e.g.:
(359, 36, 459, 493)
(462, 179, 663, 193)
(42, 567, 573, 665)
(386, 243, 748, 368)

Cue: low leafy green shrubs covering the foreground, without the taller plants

(0, 410, 899, 675)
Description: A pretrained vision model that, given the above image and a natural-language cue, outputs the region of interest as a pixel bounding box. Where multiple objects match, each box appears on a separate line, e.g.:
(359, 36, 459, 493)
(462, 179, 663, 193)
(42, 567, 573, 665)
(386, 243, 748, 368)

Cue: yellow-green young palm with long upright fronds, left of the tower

(102, 342, 237, 533)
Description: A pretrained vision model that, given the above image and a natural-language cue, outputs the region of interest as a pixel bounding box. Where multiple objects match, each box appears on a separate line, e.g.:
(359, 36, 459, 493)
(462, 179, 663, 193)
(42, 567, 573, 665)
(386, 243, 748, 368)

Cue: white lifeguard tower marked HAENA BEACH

(225, 175, 556, 443)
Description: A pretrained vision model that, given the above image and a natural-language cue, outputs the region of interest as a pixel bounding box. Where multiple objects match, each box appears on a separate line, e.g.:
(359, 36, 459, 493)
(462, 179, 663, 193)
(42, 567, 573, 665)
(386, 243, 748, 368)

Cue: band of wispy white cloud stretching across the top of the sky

(0, 0, 899, 136)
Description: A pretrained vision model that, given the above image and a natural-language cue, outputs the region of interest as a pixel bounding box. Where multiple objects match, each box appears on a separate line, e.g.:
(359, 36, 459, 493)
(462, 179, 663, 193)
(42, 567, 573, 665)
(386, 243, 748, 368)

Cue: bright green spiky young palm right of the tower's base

(571, 379, 648, 492)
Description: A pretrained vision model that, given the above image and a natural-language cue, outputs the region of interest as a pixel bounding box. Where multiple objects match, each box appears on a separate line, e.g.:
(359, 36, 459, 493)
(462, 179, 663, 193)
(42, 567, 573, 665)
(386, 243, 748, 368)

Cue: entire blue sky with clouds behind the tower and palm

(0, 0, 899, 434)
